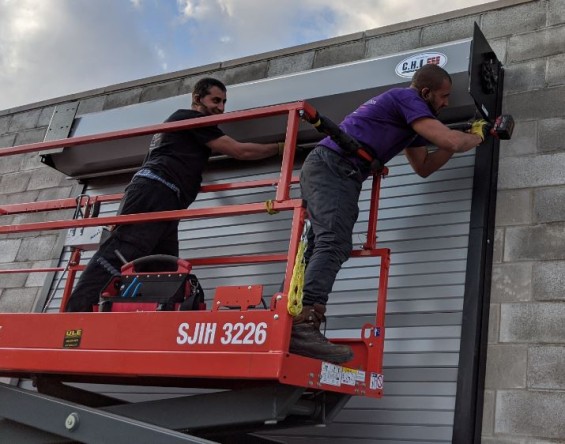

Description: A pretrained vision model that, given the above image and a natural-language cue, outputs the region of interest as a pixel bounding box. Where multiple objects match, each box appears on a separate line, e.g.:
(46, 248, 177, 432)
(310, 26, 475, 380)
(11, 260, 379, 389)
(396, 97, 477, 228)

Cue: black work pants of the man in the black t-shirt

(66, 177, 182, 311)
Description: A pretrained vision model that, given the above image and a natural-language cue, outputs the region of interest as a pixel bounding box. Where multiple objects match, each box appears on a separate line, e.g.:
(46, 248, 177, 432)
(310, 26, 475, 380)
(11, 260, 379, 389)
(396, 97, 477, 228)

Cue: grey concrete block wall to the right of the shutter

(483, 0, 565, 444)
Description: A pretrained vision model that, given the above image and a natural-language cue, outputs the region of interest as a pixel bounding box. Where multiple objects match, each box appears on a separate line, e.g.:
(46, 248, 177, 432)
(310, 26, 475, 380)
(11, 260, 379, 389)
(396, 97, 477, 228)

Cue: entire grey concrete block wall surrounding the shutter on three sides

(0, 0, 565, 444)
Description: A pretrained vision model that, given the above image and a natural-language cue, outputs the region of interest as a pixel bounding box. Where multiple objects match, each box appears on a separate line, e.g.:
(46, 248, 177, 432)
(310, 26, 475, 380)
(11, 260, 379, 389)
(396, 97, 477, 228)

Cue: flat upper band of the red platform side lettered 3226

(0, 310, 290, 353)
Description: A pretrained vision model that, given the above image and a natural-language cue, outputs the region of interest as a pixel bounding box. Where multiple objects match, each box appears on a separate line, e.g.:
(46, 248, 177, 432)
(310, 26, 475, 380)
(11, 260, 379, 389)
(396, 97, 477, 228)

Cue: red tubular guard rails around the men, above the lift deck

(0, 101, 387, 298)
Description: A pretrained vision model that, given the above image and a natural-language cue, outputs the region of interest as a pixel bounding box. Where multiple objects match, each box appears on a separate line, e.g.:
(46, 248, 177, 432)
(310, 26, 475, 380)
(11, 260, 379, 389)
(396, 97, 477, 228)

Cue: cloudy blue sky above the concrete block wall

(0, 0, 492, 110)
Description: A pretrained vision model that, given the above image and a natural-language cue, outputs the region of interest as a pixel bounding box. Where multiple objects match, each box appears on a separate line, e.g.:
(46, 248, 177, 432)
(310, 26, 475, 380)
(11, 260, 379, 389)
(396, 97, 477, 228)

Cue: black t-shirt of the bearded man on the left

(143, 109, 224, 206)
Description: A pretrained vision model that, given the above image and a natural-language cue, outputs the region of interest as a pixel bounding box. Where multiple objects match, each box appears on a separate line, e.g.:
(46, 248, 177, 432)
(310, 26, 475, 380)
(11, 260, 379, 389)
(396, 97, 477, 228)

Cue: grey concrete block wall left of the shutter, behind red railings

(0, 105, 80, 312)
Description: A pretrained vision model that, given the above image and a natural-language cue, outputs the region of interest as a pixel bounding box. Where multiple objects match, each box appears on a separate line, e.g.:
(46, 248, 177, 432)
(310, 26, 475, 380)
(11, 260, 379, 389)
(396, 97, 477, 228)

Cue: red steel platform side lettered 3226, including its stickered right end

(0, 310, 382, 396)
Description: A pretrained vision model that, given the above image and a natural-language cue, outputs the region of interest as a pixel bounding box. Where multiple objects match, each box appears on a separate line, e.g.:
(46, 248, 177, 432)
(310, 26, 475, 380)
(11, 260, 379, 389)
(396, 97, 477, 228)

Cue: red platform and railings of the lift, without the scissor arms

(0, 102, 390, 397)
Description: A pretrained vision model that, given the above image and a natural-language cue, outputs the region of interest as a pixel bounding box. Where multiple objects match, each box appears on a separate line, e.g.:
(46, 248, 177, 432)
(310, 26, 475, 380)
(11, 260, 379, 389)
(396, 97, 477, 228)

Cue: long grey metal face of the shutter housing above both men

(68, 39, 471, 137)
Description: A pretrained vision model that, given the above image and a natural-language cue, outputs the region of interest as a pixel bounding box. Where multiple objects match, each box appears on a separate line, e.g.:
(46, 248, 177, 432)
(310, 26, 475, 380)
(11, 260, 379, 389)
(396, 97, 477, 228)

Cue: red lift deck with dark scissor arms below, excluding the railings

(0, 258, 383, 443)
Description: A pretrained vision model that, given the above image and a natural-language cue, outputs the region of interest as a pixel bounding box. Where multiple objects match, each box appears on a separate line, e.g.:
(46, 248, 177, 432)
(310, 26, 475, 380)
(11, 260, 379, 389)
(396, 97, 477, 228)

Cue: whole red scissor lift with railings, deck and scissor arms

(0, 102, 390, 443)
